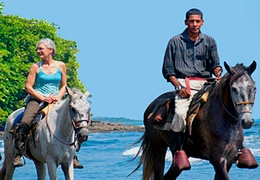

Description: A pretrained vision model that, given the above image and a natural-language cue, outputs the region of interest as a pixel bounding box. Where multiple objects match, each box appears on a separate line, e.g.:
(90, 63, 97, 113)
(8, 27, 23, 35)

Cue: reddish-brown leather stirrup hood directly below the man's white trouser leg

(174, 150, 191, 171)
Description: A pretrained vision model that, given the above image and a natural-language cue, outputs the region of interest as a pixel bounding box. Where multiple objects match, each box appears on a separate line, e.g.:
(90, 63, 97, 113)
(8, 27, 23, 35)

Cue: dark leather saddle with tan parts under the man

(147, 82, 215, 135)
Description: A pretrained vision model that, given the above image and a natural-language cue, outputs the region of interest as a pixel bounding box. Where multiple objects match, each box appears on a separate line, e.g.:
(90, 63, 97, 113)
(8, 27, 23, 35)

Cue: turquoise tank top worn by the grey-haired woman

(35, 61, 62, 96)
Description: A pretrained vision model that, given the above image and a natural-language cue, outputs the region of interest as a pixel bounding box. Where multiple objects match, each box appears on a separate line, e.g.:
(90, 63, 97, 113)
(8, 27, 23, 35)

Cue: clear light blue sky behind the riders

(0, 0, 260, 120)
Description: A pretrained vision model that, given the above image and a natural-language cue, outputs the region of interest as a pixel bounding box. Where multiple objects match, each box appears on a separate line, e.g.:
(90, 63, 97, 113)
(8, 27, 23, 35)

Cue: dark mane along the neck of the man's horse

(213, 63, 247, 96)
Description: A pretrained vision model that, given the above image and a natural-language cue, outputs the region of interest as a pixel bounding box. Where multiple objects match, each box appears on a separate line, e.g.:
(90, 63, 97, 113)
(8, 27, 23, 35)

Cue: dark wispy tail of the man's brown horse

(128, 131, 154, 180)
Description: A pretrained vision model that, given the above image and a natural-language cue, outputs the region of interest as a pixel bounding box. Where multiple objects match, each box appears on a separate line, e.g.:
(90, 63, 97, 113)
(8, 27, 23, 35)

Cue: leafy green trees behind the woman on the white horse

(0, 3, 85, 122)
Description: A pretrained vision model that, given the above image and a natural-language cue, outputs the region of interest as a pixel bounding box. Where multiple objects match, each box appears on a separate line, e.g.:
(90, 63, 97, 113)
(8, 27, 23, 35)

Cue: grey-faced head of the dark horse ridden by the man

(224, 61, 256, 129)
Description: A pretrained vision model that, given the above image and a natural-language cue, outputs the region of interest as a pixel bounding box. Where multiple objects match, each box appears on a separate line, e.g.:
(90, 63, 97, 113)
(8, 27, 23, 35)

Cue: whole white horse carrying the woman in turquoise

(0, 88, 90, 180)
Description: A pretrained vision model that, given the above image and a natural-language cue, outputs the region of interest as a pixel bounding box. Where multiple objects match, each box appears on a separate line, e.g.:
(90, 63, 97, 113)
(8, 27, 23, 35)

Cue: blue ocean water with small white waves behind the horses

(0, 118, 260, 180)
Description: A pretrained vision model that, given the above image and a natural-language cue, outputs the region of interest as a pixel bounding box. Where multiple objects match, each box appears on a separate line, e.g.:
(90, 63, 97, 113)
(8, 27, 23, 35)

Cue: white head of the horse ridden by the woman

(66, 87, 91, 143)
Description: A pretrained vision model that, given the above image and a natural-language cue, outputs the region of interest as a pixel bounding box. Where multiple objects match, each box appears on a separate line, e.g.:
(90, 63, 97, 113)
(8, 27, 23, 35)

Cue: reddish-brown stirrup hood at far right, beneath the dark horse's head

(236, 148, 258, 169)
